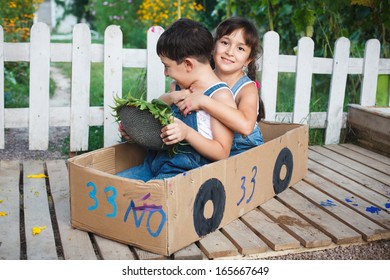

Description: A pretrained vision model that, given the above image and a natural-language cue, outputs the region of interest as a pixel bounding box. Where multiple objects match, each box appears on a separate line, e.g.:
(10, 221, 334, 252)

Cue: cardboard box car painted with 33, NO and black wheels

(69, 122, 308, 256)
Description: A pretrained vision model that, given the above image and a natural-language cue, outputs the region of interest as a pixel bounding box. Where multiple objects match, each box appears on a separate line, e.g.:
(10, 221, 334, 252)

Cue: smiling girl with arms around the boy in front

(172, 17, 264, 155)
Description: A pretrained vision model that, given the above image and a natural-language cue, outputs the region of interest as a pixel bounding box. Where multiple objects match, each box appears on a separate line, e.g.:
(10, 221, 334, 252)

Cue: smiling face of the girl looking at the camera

(213, 29, 251, 72)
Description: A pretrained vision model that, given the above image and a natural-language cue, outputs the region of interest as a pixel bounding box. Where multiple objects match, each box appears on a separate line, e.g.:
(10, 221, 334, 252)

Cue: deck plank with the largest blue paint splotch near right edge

(304, 171, 390, 229)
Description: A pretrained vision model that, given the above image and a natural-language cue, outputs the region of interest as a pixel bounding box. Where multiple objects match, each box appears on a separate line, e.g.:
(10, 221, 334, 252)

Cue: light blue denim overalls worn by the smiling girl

(230, 75, 264, 156)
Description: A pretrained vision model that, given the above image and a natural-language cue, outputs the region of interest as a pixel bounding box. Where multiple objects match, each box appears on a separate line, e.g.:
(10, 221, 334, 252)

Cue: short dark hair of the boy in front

(157, 18, 214, 64)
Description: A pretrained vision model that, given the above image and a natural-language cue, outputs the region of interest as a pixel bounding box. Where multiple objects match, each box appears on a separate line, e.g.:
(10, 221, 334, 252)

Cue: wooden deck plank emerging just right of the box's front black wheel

(221, 219, 269, 255)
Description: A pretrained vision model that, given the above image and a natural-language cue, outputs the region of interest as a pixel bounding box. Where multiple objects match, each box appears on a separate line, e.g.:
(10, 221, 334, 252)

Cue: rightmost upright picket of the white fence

(360, 39, 381, 106)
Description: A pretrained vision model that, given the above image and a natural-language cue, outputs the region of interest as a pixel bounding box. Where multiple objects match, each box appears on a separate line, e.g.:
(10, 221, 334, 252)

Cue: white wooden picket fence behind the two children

(0, 23, 390, 151)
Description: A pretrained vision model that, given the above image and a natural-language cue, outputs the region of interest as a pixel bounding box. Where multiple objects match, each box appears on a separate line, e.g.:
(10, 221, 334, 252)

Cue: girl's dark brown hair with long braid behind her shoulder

(214, 17, 265, 121)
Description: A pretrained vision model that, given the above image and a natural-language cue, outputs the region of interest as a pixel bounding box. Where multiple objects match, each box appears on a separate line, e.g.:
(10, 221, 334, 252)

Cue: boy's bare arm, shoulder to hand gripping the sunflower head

(161, 90, 235, 161)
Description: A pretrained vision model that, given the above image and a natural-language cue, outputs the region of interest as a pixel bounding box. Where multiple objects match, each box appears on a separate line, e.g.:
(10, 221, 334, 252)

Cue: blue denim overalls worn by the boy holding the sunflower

(116, 83, 228, 182)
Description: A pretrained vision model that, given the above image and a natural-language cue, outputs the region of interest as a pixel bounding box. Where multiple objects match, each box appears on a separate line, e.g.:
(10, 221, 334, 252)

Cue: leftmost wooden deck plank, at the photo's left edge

(0, 161, 21, 260)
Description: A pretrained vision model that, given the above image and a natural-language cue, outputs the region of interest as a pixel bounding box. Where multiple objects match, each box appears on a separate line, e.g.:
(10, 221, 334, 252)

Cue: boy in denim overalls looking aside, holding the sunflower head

(117, 19, 236, 181)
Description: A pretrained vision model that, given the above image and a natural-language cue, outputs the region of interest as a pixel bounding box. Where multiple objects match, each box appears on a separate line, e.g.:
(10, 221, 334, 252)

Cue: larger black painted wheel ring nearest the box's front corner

(193, 178, 226, 237)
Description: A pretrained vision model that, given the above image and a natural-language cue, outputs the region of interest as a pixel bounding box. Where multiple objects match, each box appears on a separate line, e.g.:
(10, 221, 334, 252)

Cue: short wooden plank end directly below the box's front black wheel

(198, 230, 238, 259)
